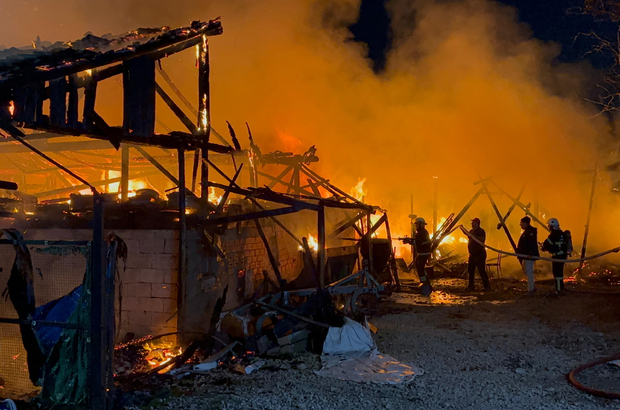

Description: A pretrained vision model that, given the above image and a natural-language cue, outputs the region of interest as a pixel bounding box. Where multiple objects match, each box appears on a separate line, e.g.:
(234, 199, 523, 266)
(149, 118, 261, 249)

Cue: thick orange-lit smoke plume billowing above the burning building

(0, 0, 620, 262)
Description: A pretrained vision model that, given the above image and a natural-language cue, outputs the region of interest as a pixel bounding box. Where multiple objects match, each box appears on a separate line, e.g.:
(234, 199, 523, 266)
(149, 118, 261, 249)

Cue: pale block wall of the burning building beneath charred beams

(0, 223, 303, 338)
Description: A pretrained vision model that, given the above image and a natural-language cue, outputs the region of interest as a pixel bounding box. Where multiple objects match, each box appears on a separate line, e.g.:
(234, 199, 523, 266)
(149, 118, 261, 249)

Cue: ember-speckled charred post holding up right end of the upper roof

(198, 35, 211, 200)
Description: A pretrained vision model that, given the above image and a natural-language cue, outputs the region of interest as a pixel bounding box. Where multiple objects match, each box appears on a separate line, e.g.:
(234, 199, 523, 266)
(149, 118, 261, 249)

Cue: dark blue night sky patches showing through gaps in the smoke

(350, 0, 615, 72)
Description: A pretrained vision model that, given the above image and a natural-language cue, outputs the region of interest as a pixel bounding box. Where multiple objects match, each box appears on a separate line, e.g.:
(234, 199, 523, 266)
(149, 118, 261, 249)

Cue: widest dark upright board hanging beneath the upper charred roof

(123, 56, 156, 137)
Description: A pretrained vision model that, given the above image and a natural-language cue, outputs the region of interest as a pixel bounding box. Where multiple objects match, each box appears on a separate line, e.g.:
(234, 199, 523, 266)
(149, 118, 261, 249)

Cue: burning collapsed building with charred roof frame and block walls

(0, 15, 398, 403)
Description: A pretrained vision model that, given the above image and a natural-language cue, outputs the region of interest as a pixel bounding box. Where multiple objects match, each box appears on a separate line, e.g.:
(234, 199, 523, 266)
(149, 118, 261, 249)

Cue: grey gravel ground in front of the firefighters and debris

(128, 279, 620, 410)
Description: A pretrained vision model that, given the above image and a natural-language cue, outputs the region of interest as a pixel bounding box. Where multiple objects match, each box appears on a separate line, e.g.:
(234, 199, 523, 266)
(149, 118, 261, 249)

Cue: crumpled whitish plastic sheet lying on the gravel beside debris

(315, 318, 422, 384)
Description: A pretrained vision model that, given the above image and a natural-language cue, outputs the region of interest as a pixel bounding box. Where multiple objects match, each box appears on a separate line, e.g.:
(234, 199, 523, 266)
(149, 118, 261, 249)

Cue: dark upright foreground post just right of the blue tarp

(90, 193, 107, 410)
